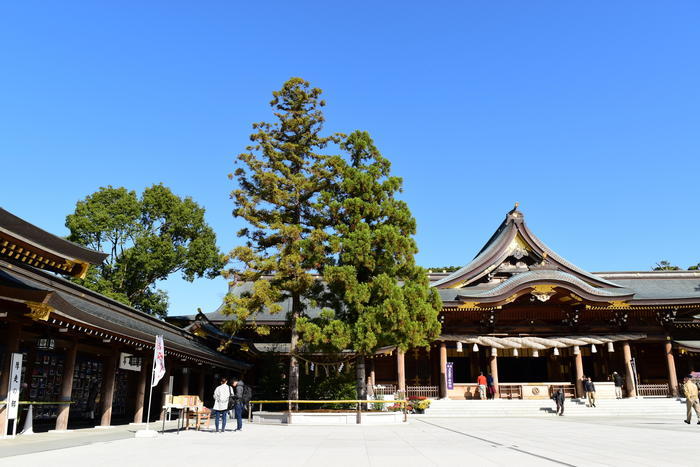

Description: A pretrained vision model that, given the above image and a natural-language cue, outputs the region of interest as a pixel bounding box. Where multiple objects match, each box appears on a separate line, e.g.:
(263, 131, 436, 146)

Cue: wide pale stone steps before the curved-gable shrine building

(424, 397, 685, 419)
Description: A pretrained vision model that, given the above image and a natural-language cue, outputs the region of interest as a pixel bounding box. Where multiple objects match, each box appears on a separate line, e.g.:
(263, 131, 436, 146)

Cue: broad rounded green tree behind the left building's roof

(66, 185, 224, 317)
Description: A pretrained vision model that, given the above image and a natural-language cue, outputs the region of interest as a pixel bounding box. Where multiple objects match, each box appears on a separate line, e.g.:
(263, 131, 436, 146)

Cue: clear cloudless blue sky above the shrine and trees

(0, 0, 700, 314)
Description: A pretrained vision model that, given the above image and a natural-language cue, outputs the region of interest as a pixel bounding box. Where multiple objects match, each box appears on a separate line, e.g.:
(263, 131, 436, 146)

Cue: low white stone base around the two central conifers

(253, 412, 404, 425)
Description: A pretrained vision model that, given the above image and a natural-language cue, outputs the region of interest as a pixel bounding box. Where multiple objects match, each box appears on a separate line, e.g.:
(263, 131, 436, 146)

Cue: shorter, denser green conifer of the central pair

(301, 131, 442, 398)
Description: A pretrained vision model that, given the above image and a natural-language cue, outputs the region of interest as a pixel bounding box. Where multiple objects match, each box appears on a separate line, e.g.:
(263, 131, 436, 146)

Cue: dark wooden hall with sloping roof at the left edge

(0, 209, 250, 434)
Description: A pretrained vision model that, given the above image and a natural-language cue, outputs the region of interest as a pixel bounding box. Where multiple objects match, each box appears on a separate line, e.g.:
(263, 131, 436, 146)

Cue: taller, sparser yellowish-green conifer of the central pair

(224, 78, 338, 399)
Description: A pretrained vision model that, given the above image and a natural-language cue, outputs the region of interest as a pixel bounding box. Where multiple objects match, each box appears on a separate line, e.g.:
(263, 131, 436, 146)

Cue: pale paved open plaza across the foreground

(0, 413, 700, 467)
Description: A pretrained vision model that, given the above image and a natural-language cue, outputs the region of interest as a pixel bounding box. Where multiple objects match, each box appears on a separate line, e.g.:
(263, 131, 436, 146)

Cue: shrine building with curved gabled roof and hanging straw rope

(206, 205, 700, 399)
